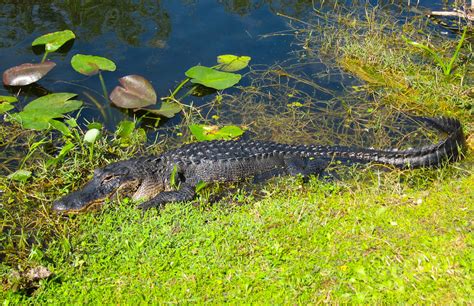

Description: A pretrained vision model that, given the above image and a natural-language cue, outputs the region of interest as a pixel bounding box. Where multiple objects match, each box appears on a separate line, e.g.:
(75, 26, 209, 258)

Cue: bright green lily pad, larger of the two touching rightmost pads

(186, 66, 242, 90)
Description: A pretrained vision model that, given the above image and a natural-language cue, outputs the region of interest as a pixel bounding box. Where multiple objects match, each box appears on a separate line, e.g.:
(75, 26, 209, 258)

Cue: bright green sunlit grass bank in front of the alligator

(3, 164, 474, 304)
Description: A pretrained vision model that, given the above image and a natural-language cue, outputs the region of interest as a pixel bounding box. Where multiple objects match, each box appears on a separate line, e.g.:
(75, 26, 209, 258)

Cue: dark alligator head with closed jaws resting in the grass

(53, 161, 159, 213)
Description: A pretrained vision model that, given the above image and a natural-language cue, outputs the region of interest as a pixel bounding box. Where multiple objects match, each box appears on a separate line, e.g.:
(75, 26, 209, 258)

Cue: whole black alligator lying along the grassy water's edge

(53, 117, 467, 212)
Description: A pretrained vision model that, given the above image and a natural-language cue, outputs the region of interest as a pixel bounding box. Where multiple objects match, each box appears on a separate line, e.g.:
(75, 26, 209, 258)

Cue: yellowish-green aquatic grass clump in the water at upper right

(293, 7, 474, 122)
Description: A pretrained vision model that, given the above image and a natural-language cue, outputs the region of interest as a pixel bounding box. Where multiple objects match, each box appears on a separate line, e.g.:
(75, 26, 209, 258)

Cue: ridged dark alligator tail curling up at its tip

(312, 117, 467, 169)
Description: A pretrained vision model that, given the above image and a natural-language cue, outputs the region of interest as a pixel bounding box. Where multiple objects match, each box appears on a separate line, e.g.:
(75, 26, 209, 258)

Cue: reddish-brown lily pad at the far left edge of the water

(3, 61, 56, 86)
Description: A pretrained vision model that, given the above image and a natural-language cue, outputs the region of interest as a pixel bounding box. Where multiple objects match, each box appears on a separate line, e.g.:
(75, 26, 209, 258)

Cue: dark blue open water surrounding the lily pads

(0, 0, 460, 127)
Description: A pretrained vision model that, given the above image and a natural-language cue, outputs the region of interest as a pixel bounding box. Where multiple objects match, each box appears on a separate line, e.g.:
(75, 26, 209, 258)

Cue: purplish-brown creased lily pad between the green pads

(110, 75, 157, 109)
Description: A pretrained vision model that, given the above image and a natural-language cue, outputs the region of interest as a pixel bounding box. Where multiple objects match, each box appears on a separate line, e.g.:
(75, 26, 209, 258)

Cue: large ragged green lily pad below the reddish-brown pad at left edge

(13, 93, 82, 134)
